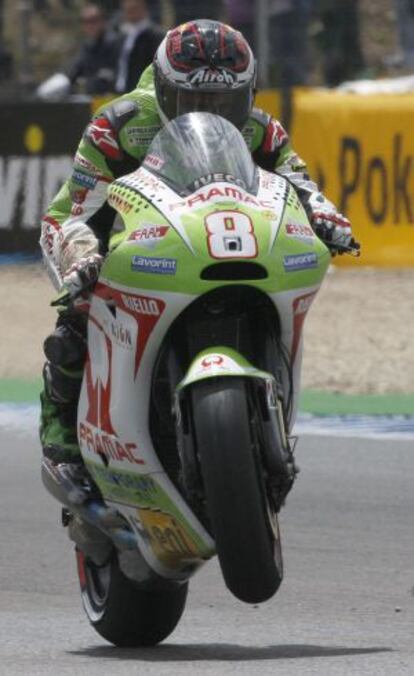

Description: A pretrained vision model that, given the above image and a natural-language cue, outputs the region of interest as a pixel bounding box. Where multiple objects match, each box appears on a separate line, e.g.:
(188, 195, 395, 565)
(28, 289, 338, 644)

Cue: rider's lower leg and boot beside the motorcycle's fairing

(40, 311, 113, 565)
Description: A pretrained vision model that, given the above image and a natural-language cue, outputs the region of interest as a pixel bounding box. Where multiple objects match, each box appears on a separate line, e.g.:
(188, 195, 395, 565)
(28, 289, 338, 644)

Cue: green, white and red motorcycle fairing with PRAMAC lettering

(79, 114, 330, 579)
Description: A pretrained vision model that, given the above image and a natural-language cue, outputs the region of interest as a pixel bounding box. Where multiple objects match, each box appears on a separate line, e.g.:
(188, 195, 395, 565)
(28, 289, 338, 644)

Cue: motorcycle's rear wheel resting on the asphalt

(76, 550, 188, 648)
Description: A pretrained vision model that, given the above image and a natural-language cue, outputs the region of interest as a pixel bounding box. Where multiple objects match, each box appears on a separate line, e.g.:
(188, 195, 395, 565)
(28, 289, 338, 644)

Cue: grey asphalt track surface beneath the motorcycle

(0, 430, 414, 676)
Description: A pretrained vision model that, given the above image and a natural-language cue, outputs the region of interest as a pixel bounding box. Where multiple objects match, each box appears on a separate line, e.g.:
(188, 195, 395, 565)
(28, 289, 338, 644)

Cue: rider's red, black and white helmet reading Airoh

(154, 19, 256, 129)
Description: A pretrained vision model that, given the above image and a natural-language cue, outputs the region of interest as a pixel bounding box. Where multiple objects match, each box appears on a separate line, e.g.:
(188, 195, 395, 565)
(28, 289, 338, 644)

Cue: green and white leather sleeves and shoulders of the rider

(40, 66, 335, 288)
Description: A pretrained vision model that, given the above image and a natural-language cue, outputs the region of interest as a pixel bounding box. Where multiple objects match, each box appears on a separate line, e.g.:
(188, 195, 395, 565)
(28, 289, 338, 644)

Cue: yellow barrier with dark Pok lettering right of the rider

(291, 90, 414, 267)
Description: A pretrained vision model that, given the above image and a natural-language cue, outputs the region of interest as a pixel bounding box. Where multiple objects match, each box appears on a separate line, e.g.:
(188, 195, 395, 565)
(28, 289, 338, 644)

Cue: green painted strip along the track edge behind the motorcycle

(0, 378, 414, 416)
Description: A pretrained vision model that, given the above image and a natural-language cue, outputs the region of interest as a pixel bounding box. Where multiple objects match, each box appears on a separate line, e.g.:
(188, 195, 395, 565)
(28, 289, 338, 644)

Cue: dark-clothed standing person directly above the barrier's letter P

(317, 0, 364, 87)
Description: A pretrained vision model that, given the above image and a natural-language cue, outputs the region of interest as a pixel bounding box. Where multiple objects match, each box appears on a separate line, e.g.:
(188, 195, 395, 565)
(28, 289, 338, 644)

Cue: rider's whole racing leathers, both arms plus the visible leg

(40, 66, 351, 461)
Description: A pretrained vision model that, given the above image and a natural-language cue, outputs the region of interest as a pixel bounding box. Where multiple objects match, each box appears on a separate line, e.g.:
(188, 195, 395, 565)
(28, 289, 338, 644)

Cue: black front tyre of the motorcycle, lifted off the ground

(191, 377, 282, 603)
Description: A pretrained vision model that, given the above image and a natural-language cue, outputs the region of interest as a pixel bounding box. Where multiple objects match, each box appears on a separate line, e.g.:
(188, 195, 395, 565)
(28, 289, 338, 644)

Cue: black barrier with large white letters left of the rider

(0, 102, 90, 254)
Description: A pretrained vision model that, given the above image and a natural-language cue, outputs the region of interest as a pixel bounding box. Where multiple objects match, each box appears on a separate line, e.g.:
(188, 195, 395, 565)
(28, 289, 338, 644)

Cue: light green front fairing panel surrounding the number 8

(102, 181, 331, 295)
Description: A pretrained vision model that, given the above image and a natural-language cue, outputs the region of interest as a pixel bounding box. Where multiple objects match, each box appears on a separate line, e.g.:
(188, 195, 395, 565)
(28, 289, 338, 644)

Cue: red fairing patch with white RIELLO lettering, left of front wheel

(94, 283, 166, 377)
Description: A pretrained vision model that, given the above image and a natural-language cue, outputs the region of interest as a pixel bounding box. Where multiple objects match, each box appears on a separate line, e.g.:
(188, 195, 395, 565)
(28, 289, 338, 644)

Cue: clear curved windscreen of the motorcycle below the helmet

(143, 113, 257, 195)
